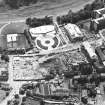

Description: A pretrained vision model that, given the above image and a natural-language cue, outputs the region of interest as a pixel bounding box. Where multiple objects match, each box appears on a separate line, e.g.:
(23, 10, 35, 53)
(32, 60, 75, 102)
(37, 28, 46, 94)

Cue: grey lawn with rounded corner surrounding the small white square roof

(0, 22, 29, 49)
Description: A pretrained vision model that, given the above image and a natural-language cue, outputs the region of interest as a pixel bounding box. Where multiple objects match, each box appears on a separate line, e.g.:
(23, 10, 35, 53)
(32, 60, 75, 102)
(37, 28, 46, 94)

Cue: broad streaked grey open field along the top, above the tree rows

(0, 0, 93, 21)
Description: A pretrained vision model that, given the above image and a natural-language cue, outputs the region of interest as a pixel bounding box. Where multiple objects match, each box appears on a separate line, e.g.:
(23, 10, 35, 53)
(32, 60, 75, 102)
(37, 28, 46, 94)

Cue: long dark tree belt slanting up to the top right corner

(57, 0, 104, 24)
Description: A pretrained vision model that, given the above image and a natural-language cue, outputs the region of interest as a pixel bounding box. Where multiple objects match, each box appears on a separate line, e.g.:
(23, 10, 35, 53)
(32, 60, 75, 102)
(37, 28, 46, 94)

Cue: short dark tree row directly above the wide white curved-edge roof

(26, 16, 53, 27)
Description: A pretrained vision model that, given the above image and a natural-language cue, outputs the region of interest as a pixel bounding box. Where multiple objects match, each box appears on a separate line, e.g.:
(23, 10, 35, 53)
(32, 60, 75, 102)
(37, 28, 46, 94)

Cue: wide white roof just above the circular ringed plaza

(29, 25, 55, 37)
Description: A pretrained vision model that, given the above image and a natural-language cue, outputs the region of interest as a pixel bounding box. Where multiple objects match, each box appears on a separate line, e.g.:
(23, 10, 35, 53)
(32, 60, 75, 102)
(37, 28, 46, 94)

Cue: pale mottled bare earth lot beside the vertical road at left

(13, 56, 47, 81)
